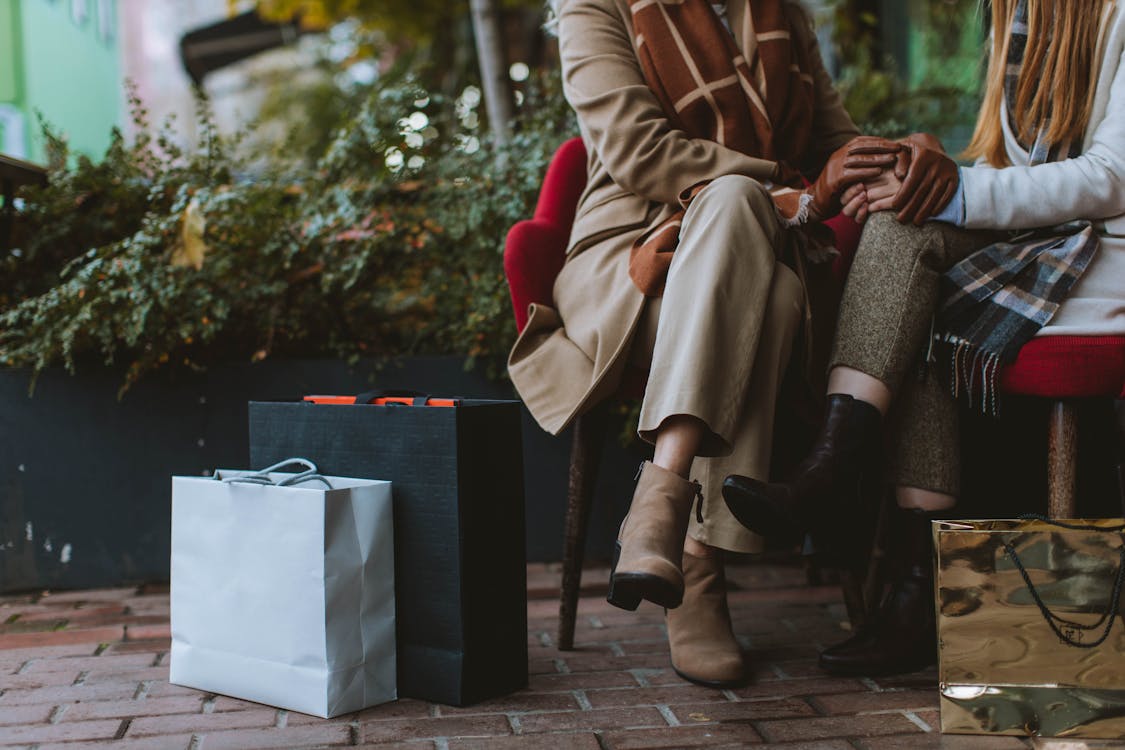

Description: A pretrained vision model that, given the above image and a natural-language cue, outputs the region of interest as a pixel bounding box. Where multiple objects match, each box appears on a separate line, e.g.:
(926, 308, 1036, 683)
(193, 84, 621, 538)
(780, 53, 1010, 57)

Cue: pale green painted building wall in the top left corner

(0, 0, 124, 162)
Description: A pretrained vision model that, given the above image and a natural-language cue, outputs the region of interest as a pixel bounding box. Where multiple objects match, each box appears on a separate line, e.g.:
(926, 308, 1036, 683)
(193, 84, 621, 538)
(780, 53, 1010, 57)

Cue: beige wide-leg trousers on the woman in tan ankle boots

(631, 175, 806, 552)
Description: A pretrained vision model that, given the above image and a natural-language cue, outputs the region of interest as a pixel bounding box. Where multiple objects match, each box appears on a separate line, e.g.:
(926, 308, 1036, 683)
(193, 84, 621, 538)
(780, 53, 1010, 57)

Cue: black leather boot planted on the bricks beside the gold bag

(820, 506, 937, 677)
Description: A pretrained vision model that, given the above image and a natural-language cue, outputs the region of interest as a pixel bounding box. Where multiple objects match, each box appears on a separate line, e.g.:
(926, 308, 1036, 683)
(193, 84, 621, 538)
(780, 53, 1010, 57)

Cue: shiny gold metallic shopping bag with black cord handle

(934, 518, 1125, 739)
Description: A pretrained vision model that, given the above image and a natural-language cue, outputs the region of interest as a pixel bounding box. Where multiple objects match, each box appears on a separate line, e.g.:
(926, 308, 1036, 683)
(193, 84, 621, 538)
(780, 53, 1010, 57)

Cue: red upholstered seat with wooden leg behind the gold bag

(1000, 336, 1125, 518)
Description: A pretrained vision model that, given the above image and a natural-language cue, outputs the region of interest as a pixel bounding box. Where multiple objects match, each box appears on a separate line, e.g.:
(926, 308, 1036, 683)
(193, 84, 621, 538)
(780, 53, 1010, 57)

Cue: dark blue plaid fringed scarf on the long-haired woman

(936, 0, 1099, 414)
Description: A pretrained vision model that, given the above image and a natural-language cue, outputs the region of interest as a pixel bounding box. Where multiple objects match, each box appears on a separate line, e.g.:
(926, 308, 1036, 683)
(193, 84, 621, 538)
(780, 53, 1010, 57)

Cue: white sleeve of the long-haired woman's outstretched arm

(961, 44, 1125, 229)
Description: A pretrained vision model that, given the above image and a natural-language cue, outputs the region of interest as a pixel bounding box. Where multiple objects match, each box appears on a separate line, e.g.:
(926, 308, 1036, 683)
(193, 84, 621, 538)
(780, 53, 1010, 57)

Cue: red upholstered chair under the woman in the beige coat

(504, 138, 860, 651)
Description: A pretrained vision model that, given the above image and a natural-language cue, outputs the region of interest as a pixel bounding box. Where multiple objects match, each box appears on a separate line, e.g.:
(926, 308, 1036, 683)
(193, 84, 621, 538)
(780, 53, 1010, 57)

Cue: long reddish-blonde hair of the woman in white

(965, 0, 1106, 166)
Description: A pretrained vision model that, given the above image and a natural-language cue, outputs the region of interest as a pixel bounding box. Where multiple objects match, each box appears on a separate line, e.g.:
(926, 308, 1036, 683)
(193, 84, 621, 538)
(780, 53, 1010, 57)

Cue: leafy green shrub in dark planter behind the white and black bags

(0, 71, 574, 391)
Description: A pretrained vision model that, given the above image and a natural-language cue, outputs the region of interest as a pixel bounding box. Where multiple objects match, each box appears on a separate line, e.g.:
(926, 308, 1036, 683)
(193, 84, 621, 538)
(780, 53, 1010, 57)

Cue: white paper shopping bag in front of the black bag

(170, 460, 396, 717)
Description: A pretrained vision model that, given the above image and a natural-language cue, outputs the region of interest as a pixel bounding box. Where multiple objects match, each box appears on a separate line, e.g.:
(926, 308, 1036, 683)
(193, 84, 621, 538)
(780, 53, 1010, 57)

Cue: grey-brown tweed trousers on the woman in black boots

(829, 211, 997, 496)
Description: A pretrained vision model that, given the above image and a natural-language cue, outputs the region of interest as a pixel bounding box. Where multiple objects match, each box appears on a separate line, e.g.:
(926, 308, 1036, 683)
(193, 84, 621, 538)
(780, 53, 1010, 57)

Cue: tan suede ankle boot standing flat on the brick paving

(667, 551, 747, 689)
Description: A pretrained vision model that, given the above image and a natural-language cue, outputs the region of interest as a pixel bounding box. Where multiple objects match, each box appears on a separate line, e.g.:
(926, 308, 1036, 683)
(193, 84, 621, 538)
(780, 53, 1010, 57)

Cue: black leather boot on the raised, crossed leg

(722, 394, 882, 558)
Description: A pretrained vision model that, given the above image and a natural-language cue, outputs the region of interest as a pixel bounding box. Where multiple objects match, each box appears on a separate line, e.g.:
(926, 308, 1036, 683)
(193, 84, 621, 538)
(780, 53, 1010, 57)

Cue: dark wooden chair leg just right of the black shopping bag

(557, 406, 609, 651)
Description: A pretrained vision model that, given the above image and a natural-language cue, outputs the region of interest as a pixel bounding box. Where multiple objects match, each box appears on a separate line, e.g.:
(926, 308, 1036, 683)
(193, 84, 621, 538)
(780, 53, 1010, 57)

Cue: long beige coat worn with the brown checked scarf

(509, 0, 858, 434)
